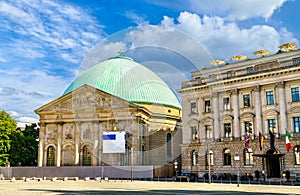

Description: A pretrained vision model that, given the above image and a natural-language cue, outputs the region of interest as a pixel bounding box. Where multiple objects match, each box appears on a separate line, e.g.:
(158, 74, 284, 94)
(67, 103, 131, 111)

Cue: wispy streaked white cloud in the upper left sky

(0, 0, 103, 64)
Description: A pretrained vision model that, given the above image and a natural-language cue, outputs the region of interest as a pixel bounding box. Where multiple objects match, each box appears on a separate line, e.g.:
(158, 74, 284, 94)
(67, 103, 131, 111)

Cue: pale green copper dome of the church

(63, 56, 181, 108)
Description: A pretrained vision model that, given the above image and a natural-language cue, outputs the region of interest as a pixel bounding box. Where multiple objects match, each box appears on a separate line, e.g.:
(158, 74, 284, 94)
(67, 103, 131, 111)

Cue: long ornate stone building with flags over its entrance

(178, 50, 300, 177)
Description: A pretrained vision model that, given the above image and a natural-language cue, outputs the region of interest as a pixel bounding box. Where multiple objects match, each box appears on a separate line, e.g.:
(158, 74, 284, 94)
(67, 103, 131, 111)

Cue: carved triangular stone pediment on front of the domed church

(35, 85, 136, 114)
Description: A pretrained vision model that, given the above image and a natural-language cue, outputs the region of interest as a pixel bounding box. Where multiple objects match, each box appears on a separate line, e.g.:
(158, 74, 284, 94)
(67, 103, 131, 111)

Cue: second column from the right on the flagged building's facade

(253, 85, 264, 136)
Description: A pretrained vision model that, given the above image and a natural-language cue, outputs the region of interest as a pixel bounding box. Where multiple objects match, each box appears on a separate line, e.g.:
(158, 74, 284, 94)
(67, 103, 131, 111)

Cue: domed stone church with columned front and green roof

(35, 56, 182, 167)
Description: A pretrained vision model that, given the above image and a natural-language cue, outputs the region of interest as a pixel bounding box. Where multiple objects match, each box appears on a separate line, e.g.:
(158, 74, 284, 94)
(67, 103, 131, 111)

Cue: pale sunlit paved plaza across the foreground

(0, 180, 300, 195)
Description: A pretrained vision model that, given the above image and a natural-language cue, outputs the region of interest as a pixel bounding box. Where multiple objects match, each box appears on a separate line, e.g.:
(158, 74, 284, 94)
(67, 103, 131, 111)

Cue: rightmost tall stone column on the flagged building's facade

(277, 82, 287, 135)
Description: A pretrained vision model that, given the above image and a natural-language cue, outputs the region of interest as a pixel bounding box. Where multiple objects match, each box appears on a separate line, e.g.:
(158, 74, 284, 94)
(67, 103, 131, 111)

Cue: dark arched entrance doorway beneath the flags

(266, 150, 280, 178)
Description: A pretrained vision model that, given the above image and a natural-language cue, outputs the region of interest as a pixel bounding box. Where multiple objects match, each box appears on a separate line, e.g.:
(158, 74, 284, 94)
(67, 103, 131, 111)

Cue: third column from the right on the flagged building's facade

(231, 89, 241, 138)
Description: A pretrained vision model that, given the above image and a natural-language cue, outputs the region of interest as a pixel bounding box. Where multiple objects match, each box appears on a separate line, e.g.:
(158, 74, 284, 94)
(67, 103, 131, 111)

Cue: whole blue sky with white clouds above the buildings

(0, 0, 300, 123)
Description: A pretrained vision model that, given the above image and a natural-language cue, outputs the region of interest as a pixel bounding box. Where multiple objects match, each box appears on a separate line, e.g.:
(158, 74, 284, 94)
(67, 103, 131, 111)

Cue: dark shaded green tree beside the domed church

(9, 123, 39, 166)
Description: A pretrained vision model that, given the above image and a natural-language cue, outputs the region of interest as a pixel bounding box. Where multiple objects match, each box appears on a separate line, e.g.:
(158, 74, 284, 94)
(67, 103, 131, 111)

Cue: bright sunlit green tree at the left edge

(0, 110, 17, 166)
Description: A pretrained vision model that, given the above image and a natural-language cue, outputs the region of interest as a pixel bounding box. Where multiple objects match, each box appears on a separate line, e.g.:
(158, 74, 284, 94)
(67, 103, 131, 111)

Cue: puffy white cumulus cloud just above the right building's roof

(162, 12, 299, 59)
